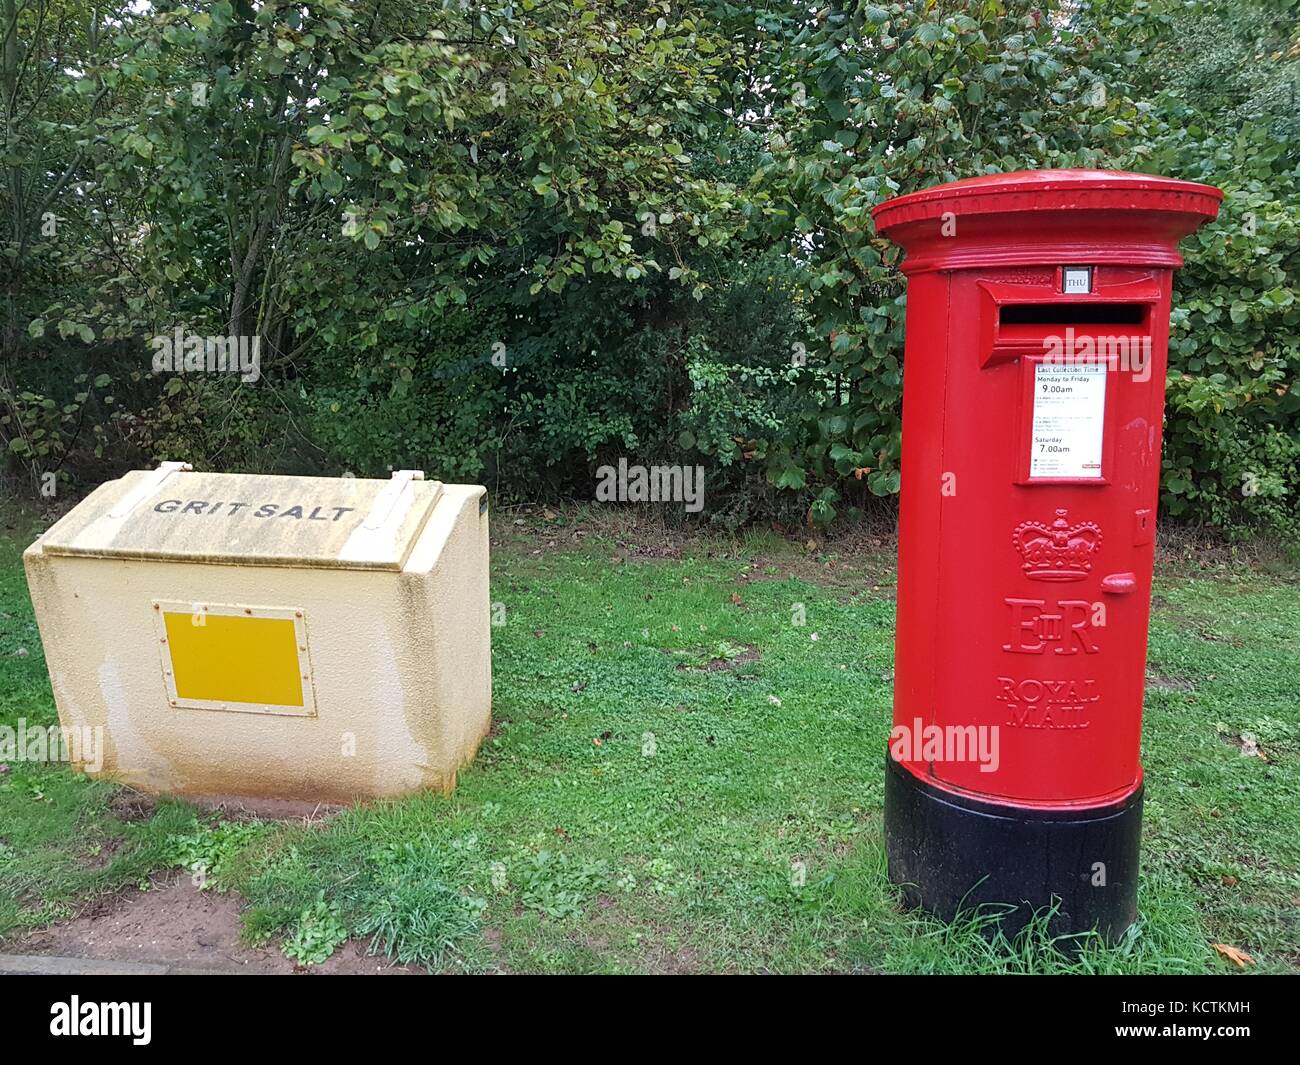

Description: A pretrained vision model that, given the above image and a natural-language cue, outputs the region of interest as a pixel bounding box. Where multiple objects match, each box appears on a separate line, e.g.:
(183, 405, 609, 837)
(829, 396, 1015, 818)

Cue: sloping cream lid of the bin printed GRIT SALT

(40, 463, 442, 571)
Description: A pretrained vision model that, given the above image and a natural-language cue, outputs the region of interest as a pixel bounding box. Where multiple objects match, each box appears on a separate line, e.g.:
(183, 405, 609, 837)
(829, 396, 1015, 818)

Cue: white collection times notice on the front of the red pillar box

(1030, 363, 1106, 479)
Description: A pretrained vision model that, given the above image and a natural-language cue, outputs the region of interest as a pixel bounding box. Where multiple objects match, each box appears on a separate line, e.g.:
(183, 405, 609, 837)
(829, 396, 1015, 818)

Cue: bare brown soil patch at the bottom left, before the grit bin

(4, 876, 423, 975)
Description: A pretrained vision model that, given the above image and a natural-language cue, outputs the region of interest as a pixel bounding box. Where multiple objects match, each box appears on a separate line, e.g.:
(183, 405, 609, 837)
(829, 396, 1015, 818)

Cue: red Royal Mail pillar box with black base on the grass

(874, 170, 1223, 939)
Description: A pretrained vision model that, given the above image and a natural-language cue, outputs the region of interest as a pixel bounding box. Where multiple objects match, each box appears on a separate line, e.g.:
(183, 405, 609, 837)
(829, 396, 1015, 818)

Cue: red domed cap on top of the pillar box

(871, 170, 1223, 274)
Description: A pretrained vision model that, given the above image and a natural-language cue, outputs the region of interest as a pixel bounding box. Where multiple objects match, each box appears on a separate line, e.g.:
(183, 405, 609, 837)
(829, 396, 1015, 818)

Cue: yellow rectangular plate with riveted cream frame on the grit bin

(153, 601, 316, 717)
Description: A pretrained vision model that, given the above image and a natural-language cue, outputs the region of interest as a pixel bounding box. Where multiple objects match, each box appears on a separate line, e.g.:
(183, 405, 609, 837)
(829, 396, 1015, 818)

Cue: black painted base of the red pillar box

(885, 756, 1143, 943)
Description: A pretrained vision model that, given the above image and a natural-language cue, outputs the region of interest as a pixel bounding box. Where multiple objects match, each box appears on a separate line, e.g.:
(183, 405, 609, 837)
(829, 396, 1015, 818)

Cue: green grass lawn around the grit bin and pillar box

(0, 507, 1300, 973)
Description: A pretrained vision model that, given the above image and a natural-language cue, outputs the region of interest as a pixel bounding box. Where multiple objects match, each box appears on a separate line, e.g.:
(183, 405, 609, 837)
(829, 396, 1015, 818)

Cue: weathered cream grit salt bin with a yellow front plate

(23, 463, 491, 801)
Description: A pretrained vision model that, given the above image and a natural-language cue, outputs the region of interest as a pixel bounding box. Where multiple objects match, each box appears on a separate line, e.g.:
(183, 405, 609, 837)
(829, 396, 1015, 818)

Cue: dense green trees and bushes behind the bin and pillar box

(0, 0, 1300, 531)
